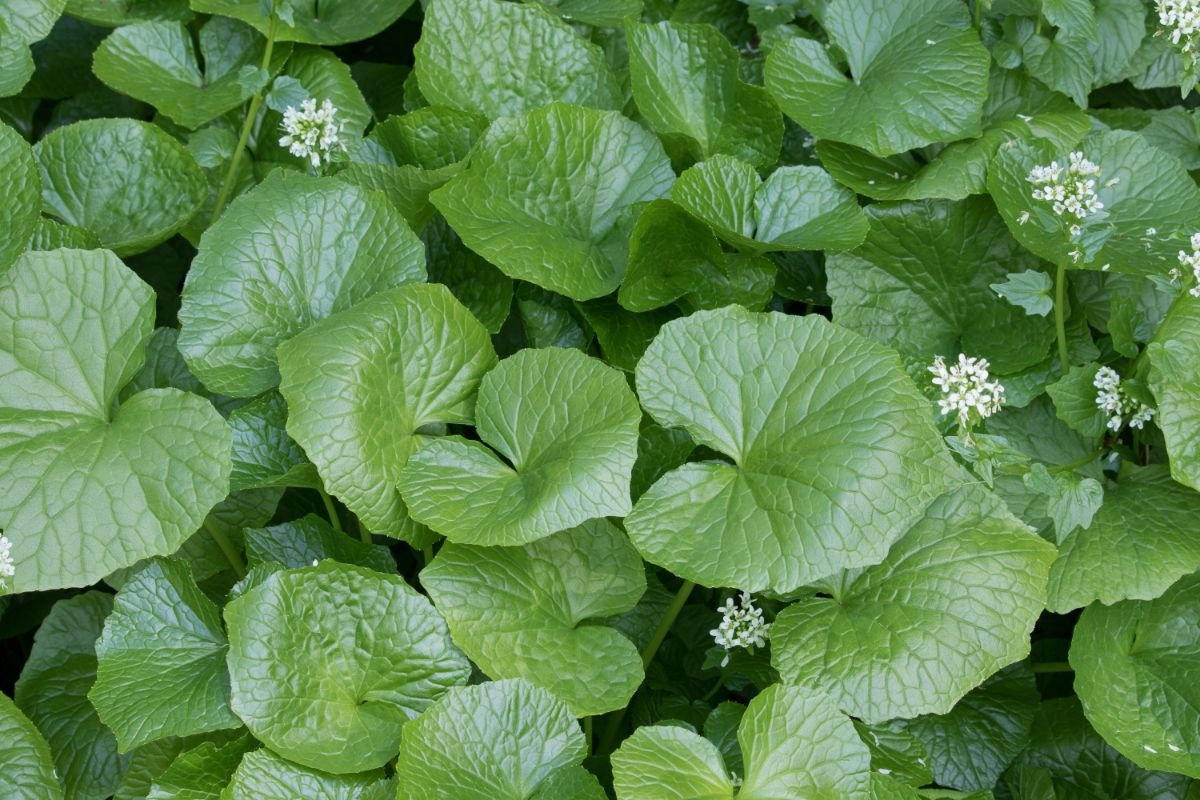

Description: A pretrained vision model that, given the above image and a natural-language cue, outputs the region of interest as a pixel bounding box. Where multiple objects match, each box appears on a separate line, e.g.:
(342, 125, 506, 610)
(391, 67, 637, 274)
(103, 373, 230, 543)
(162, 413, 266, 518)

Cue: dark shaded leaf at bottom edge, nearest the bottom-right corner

(1018, 697, 1192, 800)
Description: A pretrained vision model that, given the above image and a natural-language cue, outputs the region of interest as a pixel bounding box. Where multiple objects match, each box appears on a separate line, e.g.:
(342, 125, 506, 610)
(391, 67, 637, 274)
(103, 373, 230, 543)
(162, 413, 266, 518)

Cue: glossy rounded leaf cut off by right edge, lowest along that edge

(1070, 575, 1200, 777)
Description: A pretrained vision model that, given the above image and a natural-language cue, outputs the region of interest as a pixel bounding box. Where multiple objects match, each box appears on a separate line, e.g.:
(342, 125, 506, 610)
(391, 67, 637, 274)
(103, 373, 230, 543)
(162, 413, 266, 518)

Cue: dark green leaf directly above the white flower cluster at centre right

(826, 198, 1054, 374)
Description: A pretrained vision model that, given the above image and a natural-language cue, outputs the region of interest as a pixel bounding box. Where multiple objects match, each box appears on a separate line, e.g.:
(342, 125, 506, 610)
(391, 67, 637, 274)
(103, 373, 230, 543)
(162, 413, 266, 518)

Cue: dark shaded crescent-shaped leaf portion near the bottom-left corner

(13, 591, 128, 800)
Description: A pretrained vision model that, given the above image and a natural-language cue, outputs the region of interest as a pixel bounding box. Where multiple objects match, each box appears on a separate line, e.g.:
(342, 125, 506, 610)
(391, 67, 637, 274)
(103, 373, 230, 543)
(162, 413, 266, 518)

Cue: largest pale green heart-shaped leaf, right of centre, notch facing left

(625, 306, 956, 593)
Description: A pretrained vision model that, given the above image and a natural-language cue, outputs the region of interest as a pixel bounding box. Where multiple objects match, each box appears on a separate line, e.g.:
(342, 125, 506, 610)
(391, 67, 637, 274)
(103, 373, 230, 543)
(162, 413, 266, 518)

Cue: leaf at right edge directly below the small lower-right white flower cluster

(1046, 464, 1200, 613)
